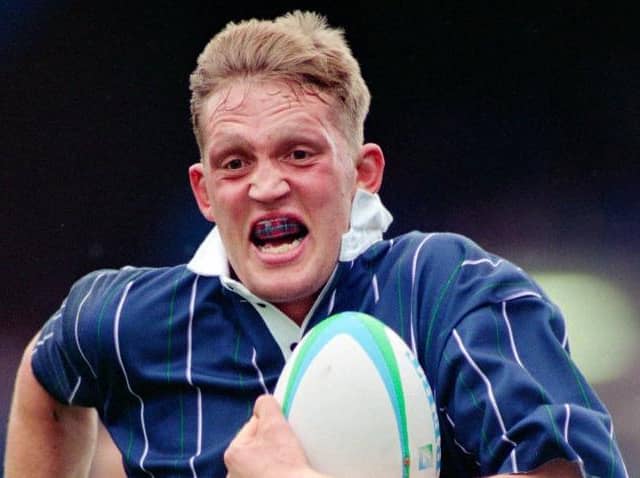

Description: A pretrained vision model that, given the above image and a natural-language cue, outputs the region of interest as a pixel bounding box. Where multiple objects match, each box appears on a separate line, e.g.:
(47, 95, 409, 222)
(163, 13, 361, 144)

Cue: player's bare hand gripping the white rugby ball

(224, 395, 330, 478)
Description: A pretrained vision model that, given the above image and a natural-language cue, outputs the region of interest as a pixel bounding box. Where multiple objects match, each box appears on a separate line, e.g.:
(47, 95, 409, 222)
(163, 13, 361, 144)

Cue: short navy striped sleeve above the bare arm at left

(31, 271, 116, 406)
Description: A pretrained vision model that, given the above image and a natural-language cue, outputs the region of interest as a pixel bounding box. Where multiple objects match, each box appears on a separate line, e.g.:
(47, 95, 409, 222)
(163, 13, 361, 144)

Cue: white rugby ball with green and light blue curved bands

(274, 312, 440, 478)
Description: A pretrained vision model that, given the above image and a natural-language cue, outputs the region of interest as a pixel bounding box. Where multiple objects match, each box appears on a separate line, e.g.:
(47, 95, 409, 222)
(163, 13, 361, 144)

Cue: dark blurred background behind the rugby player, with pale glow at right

(0, 0, 640, 476)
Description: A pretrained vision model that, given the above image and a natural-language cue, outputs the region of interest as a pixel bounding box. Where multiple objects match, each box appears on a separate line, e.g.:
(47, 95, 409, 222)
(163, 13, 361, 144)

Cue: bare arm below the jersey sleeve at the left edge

(5, 339, 98, 478)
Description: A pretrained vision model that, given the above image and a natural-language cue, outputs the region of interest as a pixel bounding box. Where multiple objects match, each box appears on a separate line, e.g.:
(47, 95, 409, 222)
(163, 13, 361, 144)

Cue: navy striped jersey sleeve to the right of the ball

(428, 237, 627, 478)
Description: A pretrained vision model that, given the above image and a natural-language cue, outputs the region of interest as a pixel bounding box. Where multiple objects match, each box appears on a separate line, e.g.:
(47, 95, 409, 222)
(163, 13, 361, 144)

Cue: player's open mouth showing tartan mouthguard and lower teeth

(251, 216, 309, 254)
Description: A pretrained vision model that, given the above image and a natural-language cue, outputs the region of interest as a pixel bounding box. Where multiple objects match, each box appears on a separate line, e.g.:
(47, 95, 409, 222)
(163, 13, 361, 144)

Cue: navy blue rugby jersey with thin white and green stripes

(32, 233, 626, 478)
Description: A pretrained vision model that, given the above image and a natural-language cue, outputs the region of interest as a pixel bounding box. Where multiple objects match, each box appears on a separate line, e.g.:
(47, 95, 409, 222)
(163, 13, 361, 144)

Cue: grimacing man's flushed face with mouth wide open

(190, 81, 358, 321)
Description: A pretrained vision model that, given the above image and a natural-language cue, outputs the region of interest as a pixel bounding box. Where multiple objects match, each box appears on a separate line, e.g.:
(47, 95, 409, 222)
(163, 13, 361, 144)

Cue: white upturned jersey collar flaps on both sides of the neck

(187, 189, 393, 278)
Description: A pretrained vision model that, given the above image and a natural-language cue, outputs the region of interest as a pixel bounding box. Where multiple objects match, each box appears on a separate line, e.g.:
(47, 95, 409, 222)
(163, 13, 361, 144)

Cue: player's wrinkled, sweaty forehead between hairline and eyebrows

(202, 80, 336, 141)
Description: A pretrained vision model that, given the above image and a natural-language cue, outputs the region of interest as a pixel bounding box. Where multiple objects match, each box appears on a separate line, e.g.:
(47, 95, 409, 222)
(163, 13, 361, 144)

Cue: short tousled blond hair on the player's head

(190, 11, 371, 153)
